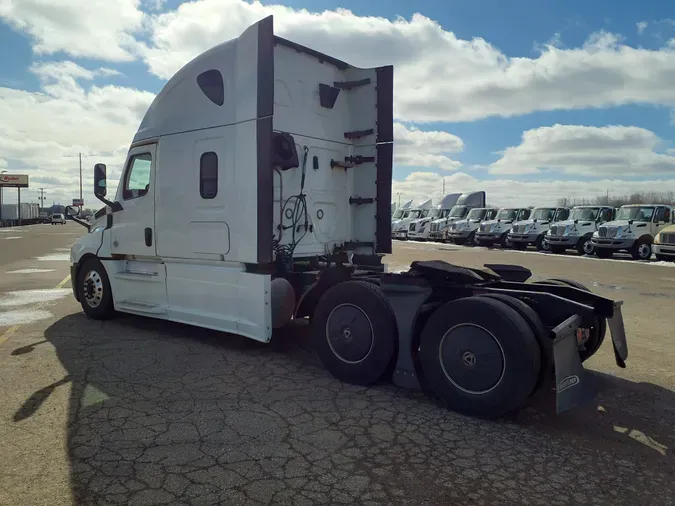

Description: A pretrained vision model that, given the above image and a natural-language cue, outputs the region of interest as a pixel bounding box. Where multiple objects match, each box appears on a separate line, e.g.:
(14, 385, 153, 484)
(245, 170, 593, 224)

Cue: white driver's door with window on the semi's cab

(110, 144, 157, 257)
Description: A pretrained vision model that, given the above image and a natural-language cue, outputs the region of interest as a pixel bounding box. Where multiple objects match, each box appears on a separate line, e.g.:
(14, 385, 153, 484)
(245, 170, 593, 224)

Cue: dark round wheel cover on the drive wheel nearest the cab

(326, 304, 375, 364)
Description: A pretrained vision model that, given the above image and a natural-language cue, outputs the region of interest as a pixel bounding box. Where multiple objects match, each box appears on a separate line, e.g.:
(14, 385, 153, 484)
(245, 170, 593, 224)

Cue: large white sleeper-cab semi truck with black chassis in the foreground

(68, 16, 627, 417)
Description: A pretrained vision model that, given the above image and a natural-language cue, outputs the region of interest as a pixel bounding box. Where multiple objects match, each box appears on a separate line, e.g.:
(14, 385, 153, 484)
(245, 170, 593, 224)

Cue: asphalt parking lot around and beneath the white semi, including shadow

(0, 223, 675, 506)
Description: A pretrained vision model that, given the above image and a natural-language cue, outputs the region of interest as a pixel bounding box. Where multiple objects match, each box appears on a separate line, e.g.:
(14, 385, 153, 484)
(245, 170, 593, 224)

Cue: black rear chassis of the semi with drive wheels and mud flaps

(288, 261, 627, 418)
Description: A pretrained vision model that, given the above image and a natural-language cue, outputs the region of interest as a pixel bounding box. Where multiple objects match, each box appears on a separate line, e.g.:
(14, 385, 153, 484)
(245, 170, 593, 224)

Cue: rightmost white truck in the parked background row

(591, 204, 673, 260)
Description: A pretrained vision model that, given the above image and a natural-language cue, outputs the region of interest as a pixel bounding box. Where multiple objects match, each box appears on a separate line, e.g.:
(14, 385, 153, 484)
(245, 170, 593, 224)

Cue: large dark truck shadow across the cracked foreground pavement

(14, 314, 675, 505)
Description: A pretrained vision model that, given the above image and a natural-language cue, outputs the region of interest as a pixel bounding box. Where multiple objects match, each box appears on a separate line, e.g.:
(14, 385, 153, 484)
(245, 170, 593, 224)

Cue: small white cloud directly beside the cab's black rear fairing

(394, 123, 464, 170)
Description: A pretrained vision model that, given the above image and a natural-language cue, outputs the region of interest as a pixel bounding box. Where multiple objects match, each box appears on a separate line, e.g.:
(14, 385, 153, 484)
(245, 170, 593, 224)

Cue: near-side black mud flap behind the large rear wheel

(551, 315, 597, 413)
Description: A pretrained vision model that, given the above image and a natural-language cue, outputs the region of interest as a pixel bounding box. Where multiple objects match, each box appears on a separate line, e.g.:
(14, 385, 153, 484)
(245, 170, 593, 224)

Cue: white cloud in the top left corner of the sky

(0, 0, 144, 61)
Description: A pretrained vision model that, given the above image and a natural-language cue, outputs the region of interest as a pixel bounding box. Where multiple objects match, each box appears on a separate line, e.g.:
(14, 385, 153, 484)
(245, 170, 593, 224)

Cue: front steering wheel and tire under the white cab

(76, 258, 115, 320)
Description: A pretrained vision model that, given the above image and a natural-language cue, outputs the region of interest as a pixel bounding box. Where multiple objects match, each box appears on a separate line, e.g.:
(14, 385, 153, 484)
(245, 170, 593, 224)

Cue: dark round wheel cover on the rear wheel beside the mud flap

(438, 323, 506, 395)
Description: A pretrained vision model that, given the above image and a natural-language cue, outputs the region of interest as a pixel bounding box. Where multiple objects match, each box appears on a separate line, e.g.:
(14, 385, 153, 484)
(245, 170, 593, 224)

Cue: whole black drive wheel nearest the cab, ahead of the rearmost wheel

(311, 280, 398, 386)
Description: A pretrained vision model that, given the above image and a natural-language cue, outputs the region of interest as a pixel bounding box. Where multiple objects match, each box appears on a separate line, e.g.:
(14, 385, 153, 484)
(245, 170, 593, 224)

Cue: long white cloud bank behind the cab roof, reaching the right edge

(142, 0, 675, 122)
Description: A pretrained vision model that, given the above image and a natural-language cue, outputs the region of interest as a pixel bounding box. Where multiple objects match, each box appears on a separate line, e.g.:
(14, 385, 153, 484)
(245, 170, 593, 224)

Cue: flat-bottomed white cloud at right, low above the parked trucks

(490, 125, 675, 177)
